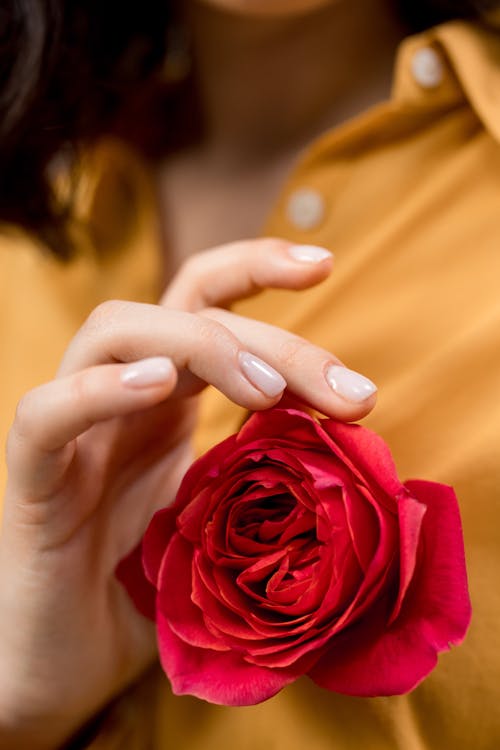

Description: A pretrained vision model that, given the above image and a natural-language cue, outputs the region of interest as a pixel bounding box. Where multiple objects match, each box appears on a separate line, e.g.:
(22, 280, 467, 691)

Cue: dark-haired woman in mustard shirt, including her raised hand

(0, 0, 500, 750)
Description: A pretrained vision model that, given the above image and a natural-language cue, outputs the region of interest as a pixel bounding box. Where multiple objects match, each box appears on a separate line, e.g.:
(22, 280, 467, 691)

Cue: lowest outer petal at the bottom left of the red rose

(157, 613, 298, 706)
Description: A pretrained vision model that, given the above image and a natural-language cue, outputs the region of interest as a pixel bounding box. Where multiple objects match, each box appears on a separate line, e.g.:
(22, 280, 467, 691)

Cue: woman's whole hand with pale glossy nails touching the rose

(0, 240, 375, 750)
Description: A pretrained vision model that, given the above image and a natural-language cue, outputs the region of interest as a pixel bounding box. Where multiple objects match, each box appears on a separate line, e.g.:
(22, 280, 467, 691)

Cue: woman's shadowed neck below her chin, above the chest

(187, 0, 407, 166)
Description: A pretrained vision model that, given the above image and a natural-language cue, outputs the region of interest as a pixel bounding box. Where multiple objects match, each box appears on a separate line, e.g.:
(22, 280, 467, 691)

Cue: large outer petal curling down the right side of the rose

(309, 481, 471, 696)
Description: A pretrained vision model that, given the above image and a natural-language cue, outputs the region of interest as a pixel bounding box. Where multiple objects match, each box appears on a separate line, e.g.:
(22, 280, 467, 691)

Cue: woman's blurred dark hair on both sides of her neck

(0, 0, 500, 258)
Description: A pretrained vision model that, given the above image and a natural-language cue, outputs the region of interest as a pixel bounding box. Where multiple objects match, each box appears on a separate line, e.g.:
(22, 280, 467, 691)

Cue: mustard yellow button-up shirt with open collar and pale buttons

(0, 22, 500, 750)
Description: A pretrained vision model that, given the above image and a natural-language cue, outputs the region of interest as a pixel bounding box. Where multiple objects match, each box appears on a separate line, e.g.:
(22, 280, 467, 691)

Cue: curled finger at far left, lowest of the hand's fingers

(7, 357, 177, 491)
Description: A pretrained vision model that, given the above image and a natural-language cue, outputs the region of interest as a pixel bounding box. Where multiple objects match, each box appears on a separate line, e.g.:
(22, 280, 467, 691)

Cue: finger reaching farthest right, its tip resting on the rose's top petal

(202, 308, 377, 421)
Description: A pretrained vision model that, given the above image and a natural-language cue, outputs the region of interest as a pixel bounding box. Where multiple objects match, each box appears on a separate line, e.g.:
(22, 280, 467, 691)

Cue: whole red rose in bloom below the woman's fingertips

(117, 409, 470, 705)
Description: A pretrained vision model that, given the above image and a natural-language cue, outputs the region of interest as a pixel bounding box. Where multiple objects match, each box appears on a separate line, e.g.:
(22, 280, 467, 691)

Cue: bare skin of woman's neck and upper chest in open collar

(158, 0, 407, 268)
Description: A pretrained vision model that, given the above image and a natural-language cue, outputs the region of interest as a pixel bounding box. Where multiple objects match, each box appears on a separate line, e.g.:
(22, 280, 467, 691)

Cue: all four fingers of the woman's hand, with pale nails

(9, 228, 368, 500)
